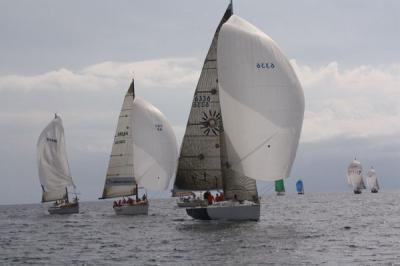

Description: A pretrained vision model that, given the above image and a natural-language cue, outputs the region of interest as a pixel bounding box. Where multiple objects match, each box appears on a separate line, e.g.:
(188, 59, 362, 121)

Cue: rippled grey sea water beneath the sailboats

(0, 191, 400, 265)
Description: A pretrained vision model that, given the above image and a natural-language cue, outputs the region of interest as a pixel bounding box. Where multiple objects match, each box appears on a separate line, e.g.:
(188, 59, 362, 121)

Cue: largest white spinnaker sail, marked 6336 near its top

(217, 15, 304, 181)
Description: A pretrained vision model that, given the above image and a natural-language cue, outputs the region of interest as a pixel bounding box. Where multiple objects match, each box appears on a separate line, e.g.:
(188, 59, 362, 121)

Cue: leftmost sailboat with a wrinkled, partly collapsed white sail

(37, 114, 79, 214)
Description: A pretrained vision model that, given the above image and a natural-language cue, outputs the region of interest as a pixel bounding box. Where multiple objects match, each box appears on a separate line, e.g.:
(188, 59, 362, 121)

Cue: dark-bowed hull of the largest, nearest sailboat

(186, 202, 260, 221)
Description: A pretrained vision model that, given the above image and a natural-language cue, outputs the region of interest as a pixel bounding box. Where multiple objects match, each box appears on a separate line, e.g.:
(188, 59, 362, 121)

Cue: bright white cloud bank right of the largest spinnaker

(292, 61, 400, 142)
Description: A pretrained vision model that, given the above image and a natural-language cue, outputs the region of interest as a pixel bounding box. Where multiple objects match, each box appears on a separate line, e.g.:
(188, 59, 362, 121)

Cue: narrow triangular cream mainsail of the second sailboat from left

(102, 80, 136, 198)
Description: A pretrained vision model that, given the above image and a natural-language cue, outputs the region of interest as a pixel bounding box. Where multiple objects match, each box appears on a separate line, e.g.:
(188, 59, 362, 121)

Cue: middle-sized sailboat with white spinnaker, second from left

(100, 80, 178, 215)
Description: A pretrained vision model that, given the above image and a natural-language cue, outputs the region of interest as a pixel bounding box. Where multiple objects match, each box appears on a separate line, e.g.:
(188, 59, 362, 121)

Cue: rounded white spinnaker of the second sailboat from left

(132, 97, 178, 191)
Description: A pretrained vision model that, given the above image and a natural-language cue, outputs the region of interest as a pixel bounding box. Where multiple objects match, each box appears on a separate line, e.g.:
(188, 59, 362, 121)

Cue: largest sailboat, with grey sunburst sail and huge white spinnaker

(173, 3, 304, 221)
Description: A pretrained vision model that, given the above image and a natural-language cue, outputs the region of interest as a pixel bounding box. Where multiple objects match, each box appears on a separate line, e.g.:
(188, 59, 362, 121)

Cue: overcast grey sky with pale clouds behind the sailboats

(0, 0, 400, 204)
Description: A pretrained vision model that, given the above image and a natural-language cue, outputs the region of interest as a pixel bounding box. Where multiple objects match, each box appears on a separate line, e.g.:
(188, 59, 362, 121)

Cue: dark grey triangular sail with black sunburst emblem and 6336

(173, 5, 232, 195)
